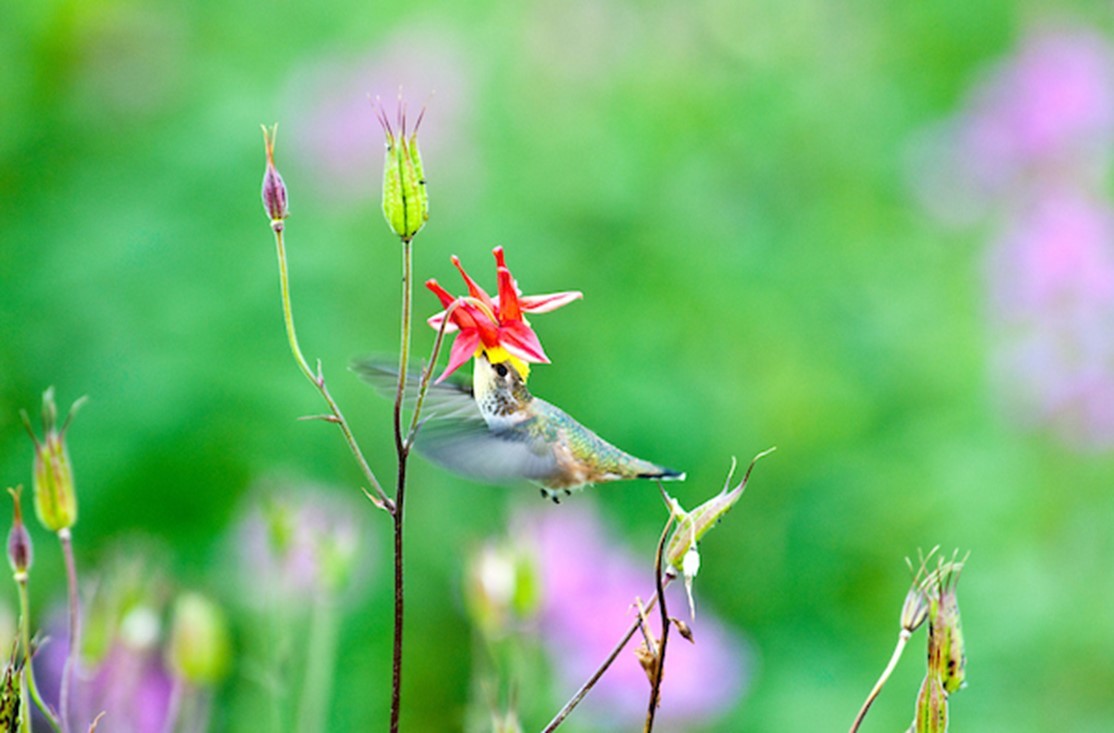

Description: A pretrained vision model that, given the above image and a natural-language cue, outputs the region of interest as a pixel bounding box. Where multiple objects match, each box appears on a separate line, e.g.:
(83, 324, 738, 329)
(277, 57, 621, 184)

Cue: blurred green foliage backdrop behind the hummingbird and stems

(0, 0, 1114, 733)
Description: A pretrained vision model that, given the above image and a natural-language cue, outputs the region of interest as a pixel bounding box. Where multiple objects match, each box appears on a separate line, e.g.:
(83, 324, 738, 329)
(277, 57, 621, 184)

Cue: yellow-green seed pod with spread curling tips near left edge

(20, 387, 85, 532)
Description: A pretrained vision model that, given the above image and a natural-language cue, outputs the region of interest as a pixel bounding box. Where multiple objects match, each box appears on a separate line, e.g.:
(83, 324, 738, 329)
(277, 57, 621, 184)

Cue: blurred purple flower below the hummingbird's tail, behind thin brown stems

(520, 502, 747, 731)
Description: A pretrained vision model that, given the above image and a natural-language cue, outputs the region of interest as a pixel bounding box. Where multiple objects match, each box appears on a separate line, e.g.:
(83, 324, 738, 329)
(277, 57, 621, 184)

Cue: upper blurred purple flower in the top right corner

(911, 26, 1114, 224)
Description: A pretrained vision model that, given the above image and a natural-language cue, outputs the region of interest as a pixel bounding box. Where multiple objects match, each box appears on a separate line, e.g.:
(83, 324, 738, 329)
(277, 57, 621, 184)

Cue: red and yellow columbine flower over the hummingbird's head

(426, 247, 584, 381)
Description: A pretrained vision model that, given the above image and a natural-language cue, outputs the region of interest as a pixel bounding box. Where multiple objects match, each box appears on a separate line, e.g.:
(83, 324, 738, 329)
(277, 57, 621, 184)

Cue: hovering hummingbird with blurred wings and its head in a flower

(355, 352, 685, 504)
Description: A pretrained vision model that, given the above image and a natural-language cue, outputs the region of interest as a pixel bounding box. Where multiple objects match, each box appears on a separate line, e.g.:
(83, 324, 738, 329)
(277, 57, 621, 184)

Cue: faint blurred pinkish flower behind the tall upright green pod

(287, 28, 473, 205)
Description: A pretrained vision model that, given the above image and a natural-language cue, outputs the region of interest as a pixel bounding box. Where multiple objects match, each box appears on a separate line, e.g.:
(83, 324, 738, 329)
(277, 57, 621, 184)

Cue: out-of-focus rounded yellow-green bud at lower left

(166, 593, 232, 685)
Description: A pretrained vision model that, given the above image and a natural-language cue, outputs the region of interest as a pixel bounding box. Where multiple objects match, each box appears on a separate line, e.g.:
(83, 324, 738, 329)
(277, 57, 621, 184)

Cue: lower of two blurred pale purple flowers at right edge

(988, 190, 1114, 447)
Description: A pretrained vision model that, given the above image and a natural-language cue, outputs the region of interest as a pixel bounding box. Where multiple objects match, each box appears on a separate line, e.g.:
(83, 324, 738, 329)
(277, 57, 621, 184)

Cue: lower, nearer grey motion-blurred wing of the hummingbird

(417, 412, 557, 482)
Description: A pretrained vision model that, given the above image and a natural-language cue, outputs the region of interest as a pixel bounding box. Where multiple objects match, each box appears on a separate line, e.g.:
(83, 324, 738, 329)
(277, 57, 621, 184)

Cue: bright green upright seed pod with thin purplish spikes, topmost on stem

(375, 99, 429, 242)
